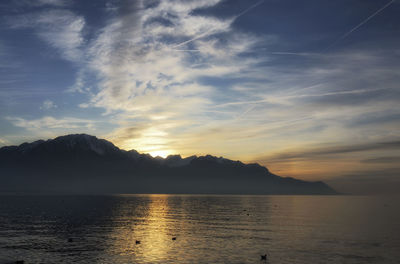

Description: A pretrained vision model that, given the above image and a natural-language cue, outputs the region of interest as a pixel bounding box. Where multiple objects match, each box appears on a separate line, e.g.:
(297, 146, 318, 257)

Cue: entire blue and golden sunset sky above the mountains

(0, 0, 400, 194)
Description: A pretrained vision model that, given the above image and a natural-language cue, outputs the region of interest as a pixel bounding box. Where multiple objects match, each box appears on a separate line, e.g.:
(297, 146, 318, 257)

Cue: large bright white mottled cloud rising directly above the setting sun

(76, 0, 264, 153)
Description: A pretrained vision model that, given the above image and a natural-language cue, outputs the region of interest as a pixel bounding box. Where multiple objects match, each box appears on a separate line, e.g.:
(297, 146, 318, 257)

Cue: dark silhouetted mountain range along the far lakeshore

(0, 134, 336, 194)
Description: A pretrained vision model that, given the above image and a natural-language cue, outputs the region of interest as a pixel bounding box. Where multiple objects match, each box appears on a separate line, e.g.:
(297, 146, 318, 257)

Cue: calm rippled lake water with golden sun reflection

(0, 195, 400, 264)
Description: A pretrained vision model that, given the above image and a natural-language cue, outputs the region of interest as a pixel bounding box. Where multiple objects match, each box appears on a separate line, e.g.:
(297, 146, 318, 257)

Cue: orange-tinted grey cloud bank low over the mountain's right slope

(248, 137, 400, 188)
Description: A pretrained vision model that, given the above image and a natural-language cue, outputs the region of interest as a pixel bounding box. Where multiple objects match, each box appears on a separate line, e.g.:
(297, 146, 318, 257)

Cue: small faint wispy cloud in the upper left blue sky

(7, 9, 85, 61)
